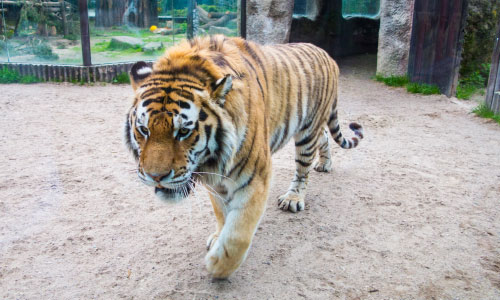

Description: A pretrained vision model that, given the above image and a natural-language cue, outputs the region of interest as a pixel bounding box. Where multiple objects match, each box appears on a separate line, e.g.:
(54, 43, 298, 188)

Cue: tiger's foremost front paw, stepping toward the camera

(205, 239, 241, 279)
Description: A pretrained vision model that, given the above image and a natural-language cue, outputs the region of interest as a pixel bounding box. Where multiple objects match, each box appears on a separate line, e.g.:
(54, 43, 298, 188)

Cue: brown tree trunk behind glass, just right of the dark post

(95, 0, 127, 27)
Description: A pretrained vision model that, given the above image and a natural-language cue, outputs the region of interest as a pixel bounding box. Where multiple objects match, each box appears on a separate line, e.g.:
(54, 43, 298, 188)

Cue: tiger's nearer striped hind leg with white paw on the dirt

(278, 130, 322, 212)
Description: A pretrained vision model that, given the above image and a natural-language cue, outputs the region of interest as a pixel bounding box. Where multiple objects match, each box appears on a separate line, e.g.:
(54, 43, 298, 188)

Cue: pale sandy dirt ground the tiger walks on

(0, 57, 500, 299)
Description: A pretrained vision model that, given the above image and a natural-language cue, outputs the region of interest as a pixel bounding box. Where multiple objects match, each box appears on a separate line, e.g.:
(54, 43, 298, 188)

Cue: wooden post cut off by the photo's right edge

(485, 22, 500, 114)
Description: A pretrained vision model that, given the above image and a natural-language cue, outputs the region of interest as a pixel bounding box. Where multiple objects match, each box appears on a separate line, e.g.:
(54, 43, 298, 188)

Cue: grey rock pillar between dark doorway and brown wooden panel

(377, 0, 414, 76)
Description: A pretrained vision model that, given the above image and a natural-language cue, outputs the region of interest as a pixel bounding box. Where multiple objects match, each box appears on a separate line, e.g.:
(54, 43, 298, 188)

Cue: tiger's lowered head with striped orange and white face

(125, 47, 235, 202)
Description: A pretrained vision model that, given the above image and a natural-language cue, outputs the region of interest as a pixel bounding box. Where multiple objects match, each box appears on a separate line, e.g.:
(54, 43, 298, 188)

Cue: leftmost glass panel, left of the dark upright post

(0, 0, 82, 65)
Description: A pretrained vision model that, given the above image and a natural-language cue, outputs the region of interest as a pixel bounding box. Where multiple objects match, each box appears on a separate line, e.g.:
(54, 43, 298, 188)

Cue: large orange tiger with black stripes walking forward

(125, 35, 363, 278)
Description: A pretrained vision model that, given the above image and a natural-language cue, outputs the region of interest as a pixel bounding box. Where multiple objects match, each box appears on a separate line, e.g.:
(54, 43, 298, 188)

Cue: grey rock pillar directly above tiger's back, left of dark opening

(247, 0, 293, 44)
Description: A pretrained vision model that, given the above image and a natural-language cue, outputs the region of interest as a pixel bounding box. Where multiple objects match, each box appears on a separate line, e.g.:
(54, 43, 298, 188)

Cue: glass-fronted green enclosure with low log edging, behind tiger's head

(0, 0, 242, 82)
